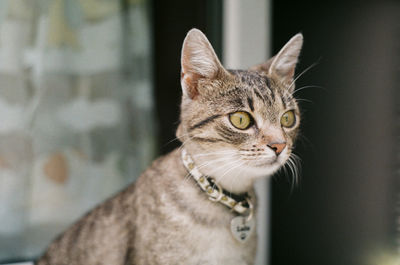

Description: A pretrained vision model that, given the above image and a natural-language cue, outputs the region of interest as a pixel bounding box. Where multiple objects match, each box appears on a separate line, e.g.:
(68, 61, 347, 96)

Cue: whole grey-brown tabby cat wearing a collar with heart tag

(35, 29, 303, 265)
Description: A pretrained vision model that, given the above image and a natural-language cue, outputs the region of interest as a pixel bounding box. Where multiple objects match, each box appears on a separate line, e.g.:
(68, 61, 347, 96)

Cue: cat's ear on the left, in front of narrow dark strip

(181, 29, 226, 99)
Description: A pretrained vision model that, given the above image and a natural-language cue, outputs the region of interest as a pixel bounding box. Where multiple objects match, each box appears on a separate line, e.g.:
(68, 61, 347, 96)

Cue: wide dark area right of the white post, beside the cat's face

(271, 0, 400, 265)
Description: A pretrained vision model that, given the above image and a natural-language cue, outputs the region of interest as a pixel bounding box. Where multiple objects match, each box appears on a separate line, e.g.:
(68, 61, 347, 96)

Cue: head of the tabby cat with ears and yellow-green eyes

(177, 29, 303, 192)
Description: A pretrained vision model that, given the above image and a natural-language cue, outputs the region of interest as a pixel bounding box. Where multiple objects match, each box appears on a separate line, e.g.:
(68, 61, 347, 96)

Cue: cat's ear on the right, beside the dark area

(250, 33, 303, 84)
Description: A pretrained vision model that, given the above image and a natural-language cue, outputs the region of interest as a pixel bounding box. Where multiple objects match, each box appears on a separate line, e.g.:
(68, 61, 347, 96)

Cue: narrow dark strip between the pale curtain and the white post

(152, 0, 222, 154)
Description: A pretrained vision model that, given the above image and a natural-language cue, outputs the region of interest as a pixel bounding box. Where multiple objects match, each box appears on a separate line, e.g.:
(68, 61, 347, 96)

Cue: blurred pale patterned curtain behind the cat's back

(0, 0, 155, 262)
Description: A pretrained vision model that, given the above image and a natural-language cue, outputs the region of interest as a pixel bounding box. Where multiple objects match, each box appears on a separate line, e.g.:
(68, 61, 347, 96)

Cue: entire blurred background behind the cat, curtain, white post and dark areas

(0, 0, 400, 265)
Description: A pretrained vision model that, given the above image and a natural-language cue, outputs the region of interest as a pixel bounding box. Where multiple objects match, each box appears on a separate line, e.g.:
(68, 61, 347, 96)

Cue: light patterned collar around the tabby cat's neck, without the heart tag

(181, 148, 253, 218)
